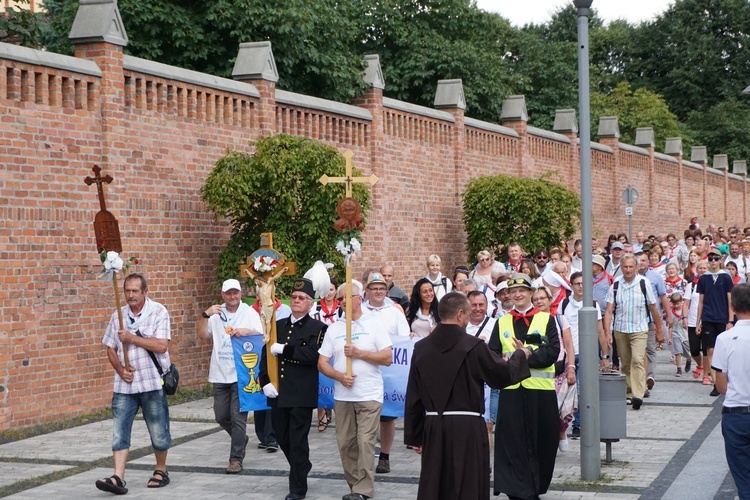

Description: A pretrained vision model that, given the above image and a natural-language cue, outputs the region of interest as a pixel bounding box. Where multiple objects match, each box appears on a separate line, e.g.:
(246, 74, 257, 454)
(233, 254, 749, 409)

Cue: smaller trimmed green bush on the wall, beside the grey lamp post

(462, 175, 581, 255)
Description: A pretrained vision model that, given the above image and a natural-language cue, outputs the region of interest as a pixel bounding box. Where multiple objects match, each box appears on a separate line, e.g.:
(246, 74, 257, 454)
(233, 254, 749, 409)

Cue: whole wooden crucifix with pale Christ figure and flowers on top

(240, 233, 297, 387)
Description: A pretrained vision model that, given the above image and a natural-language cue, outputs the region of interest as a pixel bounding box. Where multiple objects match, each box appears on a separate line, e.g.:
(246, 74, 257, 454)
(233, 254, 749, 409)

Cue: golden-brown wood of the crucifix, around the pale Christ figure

(240, 233, 297, 390)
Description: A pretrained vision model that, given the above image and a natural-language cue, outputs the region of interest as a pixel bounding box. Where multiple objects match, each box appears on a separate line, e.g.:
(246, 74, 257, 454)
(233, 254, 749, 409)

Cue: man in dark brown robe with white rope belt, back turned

(404, 292, 531, 500)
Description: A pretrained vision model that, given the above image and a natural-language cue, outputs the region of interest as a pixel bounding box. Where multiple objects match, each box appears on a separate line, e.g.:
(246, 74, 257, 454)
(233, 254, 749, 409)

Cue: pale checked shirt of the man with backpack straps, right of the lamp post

(607, 274, 656, 333)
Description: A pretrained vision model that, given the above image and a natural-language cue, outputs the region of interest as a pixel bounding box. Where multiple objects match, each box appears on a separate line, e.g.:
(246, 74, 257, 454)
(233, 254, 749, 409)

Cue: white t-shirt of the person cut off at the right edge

(711, 319, 750, 408)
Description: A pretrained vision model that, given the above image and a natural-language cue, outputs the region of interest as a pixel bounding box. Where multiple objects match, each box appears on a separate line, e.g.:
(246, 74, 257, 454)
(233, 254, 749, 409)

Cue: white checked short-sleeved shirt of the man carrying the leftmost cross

(102, 299, 172, 394)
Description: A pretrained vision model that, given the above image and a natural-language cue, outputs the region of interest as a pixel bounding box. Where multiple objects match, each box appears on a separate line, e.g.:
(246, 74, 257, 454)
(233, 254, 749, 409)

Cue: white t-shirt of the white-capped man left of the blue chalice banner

(208, 302, 263, 384)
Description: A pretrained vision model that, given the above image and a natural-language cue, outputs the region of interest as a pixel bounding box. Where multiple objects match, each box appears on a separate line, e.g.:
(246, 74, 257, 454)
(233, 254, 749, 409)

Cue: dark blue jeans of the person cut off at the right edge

(721, 413, 750, 498)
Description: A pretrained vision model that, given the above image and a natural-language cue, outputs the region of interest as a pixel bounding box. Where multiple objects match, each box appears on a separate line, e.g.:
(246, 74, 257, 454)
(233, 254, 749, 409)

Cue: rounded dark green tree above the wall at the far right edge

(688, 98, 750, 169)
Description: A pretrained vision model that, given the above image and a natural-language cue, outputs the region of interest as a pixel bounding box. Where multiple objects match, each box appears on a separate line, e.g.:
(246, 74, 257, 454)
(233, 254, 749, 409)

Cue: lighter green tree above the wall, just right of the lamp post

(591, 81, 691, 150)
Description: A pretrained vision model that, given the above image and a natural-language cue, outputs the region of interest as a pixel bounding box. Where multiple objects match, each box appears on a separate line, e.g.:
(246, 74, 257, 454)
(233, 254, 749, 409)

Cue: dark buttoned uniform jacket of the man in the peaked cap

(258, 315, 328, 408)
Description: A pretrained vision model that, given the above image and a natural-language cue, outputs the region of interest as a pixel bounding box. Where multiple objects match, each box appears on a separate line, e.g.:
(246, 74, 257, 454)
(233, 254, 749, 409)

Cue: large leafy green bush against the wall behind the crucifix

(202, 134, 371, 291)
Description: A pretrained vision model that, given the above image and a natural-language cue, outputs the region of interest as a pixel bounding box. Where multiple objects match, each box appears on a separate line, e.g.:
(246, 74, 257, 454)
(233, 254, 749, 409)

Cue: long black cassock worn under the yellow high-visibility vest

(489, 310, 560, 499)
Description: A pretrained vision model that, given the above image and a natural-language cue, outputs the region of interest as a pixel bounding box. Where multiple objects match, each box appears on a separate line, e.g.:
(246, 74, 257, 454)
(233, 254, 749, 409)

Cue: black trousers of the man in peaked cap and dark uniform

(271, 408, 315, 495)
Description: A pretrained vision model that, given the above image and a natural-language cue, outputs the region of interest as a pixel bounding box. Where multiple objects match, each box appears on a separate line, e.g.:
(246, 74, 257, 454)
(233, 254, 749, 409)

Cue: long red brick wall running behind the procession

(0, 40, 746, 429)
